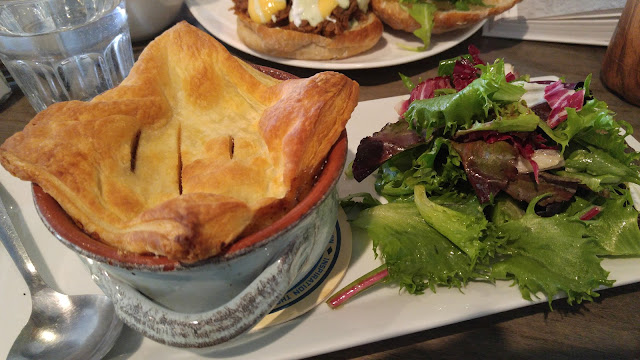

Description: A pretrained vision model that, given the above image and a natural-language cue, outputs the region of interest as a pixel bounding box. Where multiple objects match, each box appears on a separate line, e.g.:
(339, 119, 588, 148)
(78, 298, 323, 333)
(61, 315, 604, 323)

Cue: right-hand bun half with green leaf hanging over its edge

(371, 0, 521, 50)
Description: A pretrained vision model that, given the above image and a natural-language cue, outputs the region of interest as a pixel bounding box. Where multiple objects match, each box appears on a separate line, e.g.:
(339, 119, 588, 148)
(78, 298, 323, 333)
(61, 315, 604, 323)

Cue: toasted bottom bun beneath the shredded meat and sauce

(237, 12, 384, 60)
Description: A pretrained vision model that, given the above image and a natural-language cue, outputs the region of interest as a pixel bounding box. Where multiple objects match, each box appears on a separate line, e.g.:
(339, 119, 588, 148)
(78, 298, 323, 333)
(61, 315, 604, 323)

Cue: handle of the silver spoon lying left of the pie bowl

(0, 199, 47, 295)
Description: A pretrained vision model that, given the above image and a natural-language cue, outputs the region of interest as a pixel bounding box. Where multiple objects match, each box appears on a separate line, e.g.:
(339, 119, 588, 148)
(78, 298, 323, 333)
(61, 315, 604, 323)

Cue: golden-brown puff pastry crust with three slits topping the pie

(0, 22, 358, 262)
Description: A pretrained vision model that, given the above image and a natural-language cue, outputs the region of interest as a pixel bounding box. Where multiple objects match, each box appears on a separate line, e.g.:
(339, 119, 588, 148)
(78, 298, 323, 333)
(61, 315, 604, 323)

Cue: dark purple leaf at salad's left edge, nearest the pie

(352, 120, 425, 182)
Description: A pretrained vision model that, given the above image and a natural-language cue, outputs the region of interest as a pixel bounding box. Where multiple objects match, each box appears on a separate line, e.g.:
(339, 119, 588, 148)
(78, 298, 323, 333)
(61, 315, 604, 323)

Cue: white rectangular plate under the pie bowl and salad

(0, 96, 640, 360)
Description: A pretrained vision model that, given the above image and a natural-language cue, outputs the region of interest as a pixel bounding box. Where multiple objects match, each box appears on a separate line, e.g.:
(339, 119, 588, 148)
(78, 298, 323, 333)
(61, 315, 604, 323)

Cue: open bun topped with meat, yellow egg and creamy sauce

(233, 0, 383, 60)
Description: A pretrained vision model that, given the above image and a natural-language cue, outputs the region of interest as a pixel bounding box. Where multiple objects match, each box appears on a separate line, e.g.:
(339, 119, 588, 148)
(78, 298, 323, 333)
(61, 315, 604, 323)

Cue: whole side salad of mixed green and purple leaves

(327, 46, 640, 308)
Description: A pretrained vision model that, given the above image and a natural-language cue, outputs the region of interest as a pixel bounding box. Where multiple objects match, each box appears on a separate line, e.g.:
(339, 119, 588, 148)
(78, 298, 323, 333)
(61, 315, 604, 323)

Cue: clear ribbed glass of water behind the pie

(0, 0, 133, 112)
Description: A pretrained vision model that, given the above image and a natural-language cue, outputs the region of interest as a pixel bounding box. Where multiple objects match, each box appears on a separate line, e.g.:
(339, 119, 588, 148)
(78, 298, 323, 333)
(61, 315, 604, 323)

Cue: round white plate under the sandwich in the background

(187, 0, 485, 70)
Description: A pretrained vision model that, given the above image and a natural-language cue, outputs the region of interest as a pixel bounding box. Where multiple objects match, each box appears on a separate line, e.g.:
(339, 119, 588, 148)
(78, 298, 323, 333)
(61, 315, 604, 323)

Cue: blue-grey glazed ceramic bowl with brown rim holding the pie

(32, 66, 347, 348)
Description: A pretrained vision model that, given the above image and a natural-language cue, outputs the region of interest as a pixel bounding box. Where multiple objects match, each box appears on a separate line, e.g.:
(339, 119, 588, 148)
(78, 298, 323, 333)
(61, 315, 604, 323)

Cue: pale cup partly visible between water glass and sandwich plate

(127, 0, 184, 42)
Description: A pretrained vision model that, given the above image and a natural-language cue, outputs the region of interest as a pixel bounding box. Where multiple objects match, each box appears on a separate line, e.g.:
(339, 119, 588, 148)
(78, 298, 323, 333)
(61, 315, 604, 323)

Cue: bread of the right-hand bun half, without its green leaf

(370, 0, 521, 34)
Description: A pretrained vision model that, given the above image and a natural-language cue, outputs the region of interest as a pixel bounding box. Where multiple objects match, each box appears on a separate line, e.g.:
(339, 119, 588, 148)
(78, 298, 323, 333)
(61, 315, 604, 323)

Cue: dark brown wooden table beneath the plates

(0, 9, 640, 360)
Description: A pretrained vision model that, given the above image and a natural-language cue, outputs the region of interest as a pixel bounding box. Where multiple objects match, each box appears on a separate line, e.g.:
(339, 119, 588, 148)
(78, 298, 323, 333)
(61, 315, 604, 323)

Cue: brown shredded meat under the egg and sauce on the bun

(233, 0, 366, 37)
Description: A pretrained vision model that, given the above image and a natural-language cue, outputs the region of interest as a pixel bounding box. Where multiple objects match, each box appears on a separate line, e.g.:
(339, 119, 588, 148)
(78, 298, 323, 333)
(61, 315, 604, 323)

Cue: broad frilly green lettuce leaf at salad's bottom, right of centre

(491, 197, 614, 305)
